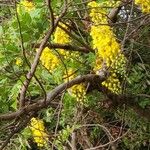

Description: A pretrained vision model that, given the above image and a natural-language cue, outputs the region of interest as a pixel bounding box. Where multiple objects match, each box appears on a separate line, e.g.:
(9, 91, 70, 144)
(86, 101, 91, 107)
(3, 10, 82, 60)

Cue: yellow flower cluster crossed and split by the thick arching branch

(64, 69, 86, 102)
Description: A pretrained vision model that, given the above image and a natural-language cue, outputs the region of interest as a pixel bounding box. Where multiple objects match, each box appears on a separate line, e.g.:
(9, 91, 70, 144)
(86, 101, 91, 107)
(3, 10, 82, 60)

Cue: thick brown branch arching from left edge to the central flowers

(0, 74, 106, 121)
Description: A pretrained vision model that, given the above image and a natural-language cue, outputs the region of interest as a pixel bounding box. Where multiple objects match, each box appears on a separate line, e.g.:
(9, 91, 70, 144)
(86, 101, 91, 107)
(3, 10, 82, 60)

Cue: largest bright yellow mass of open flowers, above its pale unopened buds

(90, 25, 120, 67)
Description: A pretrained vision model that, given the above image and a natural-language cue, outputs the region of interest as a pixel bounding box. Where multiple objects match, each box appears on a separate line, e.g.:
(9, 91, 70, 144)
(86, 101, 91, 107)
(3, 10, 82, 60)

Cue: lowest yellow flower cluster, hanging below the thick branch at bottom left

(29, 118, 48, 147)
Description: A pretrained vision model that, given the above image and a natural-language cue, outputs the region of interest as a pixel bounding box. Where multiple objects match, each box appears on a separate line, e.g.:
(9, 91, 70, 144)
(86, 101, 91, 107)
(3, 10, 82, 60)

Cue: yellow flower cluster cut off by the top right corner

(135, 0, 150, 13)
